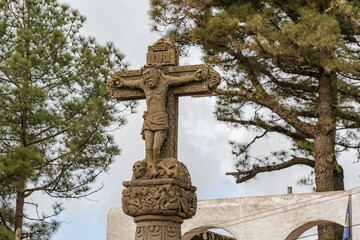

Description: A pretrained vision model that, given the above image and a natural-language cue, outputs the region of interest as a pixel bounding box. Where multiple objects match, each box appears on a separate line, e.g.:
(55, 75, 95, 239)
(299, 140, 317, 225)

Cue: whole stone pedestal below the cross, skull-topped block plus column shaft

(122, 158, 197, 240)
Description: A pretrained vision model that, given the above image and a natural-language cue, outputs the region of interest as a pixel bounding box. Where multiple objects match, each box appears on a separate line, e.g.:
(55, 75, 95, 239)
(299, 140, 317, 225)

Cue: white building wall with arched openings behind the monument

(107, 190, 360, 240)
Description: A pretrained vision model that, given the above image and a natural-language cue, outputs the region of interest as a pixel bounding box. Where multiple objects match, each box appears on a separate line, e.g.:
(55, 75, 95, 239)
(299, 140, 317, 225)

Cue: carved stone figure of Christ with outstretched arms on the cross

(113, 64, 207, 175)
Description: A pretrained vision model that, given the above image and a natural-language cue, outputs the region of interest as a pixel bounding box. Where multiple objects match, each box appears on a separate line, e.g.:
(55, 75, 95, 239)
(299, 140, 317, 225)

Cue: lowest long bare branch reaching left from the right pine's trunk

(226, 157, 315, 183)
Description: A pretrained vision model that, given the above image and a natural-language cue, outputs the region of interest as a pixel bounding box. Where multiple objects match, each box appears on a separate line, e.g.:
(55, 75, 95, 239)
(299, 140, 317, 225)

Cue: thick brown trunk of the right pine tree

(314, 73, 344, 240)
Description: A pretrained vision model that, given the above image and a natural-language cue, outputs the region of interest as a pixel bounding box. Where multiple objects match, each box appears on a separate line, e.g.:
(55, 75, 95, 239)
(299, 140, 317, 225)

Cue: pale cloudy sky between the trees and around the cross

(44, 0, 360, 240)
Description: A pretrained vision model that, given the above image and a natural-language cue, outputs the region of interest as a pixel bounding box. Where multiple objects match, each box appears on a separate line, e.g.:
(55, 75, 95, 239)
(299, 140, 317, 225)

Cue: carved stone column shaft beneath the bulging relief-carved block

(134, 215, 183, 240)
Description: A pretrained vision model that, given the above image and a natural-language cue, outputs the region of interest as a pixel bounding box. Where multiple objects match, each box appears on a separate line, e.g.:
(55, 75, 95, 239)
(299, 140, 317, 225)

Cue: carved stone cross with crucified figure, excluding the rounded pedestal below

(107, 38, 220, 172)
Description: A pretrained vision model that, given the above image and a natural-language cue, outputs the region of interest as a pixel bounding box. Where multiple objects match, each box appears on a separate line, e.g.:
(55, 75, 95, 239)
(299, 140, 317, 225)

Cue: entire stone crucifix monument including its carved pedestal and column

(107, 38, 220, 240)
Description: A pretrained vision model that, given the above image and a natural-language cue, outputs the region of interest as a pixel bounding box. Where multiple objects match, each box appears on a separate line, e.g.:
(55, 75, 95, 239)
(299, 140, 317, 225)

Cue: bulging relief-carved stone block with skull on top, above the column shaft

(122, 158, 197, 219)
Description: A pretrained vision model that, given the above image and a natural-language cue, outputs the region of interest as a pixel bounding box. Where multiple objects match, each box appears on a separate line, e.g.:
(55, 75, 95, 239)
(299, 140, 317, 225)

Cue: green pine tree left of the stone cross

(0, 0, 132, 240)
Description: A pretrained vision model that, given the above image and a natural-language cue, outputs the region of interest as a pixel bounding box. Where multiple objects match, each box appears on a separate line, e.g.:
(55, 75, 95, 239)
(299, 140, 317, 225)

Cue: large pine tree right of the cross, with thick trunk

(151, 0, 360, 239)
